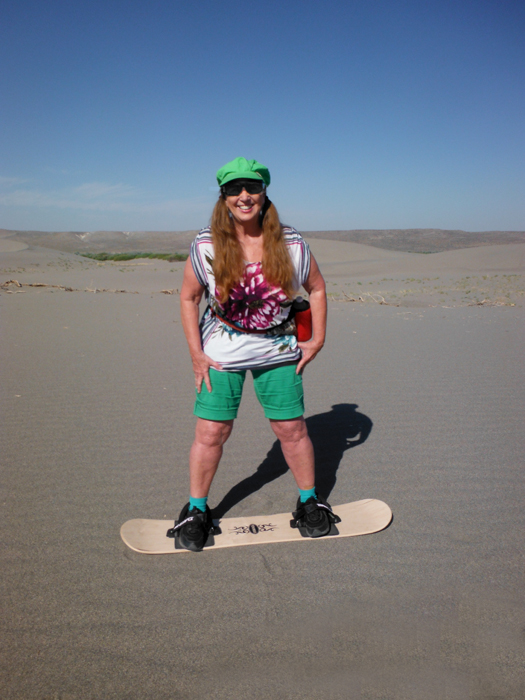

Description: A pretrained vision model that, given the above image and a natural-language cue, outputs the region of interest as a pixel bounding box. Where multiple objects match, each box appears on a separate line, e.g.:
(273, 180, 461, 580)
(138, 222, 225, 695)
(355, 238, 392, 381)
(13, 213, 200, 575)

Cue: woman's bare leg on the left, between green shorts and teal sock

(186, 418, 233, 498)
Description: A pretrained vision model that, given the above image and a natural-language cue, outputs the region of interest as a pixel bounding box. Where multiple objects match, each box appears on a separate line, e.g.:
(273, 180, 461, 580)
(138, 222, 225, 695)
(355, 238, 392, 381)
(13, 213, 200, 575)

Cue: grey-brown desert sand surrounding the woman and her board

(0, 238, 525, 700)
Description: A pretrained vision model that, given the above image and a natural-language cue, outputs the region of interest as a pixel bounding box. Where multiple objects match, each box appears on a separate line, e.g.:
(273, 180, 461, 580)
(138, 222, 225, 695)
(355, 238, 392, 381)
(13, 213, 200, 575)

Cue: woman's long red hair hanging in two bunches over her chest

(211, 195, 295, 304)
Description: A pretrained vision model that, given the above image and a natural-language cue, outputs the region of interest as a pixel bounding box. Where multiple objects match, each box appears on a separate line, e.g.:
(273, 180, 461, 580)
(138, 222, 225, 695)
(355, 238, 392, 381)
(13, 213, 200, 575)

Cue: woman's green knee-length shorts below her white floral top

(193, 364, 304, 421)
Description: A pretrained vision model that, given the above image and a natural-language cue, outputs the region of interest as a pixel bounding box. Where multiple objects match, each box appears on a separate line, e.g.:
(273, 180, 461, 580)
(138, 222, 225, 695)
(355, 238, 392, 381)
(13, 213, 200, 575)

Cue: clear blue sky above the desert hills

(0, 0, 525, 231)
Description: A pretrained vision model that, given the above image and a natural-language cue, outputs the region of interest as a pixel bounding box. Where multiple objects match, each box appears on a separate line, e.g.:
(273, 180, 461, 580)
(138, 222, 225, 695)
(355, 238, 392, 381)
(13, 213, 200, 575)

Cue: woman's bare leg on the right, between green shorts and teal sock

(270, 416, 315, 489)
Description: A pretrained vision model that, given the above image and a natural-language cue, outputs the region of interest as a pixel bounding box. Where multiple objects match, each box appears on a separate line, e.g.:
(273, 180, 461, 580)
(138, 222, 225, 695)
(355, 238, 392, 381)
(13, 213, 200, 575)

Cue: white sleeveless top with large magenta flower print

(190, 227, 310, 370)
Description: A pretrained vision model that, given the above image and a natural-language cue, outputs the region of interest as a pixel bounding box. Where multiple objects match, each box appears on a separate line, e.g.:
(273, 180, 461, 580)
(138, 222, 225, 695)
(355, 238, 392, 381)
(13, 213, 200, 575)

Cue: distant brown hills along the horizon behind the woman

(0, 228, 525, 253)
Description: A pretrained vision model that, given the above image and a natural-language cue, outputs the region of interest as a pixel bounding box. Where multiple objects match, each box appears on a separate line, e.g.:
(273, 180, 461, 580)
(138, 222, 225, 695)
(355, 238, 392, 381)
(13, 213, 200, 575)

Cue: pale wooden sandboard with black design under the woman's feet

(120, 498, 392, 554)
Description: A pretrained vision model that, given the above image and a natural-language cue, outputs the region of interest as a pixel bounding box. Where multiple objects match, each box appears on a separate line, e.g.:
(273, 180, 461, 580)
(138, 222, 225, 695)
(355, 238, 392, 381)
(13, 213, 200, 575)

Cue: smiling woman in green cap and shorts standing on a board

(172, 158, 333, 551)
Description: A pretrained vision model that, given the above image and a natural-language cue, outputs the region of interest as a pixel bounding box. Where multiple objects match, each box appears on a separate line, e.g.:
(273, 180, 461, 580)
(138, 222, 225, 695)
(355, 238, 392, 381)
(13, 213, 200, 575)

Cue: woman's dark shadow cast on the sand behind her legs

(212, 403, 373, 518)
